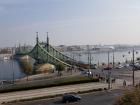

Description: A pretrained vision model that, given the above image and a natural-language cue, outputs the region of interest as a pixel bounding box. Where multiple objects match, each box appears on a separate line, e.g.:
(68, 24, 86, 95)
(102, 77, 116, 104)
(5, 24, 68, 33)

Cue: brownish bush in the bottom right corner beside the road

(114, 88, 140, 105)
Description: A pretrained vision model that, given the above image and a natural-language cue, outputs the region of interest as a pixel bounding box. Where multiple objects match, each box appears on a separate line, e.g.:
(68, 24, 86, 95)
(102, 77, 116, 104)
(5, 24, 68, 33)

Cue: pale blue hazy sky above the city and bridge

(0, 0, 140, 47)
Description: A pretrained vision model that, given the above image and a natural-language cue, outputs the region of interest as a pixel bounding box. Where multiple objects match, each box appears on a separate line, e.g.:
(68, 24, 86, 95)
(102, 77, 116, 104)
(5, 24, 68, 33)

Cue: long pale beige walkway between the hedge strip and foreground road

(0, 80, 129, 104)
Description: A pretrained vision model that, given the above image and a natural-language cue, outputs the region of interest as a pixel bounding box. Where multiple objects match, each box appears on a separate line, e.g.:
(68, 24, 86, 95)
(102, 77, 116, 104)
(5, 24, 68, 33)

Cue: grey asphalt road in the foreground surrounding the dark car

(5, 89, 123, 105)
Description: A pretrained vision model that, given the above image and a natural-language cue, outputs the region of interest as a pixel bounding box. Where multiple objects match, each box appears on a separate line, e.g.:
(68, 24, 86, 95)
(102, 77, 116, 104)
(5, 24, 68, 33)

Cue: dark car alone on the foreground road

(62, 93, 82, 103)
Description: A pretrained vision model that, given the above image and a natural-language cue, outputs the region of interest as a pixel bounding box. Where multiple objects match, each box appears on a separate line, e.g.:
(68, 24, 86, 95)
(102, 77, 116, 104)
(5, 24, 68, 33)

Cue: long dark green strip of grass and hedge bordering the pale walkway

(0, 76, 99, 93)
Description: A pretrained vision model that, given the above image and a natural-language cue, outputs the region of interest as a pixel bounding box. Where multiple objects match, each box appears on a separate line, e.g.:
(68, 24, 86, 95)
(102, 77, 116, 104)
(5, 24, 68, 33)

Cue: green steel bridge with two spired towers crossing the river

(17, 33, 82, 67)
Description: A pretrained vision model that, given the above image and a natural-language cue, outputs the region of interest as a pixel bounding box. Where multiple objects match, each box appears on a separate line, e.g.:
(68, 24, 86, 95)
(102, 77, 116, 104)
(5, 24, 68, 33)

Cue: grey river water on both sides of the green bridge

(0, 50, 140, 80)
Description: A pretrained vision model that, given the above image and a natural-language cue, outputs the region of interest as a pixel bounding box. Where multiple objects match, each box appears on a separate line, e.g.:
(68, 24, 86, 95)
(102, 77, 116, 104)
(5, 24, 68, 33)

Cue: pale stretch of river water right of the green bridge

(64, 50, 140, 65)
